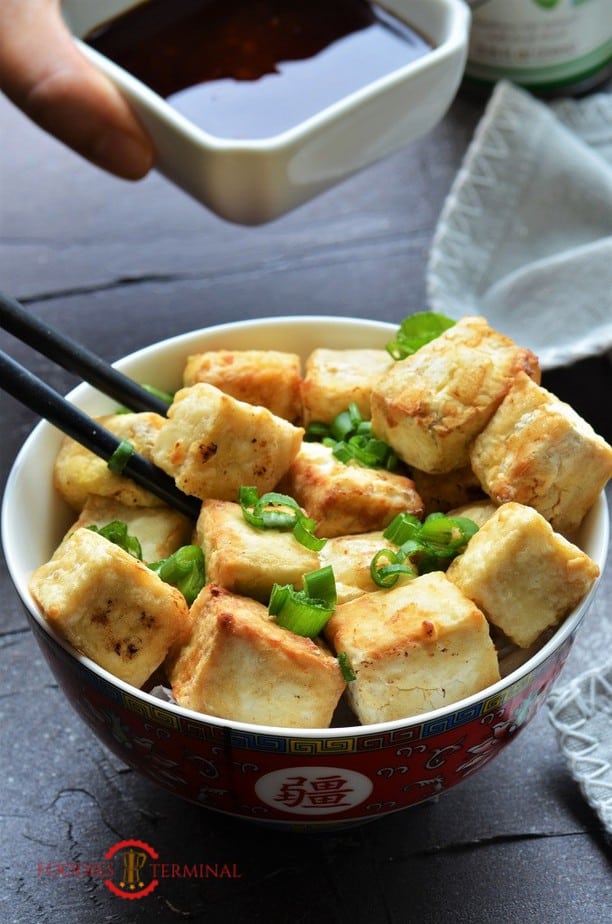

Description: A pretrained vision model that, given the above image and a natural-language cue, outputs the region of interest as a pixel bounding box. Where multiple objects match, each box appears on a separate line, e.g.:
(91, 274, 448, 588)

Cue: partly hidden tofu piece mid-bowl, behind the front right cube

(319, 530, 397, 603)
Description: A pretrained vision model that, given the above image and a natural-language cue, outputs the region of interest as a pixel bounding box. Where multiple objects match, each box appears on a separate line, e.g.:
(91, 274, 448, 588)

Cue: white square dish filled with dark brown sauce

(62, 0, 470, 225)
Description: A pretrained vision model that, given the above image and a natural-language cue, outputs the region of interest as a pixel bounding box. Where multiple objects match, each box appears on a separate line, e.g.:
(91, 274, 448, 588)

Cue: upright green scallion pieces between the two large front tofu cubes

(268, 565, 337, 638)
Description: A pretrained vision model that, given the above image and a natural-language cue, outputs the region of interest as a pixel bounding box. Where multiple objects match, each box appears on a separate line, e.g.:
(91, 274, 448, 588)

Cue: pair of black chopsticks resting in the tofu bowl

(0, 293, 200, 519)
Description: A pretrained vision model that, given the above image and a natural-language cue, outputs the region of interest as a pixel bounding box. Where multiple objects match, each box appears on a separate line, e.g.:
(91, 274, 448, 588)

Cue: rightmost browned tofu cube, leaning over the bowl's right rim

(470, 374, 612, 534)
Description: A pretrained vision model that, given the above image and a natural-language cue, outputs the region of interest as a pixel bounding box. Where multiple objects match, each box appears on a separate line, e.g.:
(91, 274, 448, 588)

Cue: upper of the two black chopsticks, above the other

(0, 292, 168, 416)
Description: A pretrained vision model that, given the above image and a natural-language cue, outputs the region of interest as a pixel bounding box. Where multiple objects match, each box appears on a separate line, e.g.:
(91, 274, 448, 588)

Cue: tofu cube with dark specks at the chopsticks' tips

(153, 382, 304, 500)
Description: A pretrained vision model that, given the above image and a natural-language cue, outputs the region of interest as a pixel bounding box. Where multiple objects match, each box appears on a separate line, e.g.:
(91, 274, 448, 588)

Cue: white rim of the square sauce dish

(71, 0, 471, 155)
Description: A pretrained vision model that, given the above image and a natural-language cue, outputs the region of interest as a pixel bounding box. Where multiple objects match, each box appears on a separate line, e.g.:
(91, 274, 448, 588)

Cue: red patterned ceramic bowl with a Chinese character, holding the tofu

(2, 317, 608, 830)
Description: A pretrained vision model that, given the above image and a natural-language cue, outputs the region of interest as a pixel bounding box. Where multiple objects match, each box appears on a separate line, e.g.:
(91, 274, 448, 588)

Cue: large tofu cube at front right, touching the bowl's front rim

(325, 571, 499, 724)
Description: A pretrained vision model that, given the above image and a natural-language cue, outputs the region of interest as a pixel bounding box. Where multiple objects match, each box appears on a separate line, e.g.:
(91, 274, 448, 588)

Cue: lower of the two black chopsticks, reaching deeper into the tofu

(0, 350, 200, 519)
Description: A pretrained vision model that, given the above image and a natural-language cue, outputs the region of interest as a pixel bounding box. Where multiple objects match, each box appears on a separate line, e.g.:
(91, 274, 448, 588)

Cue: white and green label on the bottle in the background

(466, 0, 612, 85)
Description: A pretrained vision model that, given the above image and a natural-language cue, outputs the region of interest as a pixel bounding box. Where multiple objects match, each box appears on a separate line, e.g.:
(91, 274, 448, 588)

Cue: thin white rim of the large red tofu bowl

(0, 314, 610, 739)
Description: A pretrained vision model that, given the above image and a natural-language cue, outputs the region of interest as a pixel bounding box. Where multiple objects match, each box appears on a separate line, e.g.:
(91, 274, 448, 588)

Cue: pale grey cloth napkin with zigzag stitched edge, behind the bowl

(427, 82, 612, 369)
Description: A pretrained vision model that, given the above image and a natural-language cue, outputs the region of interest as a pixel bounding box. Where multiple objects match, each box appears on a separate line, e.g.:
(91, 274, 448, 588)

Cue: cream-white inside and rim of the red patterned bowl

(2, 316, 609, 737)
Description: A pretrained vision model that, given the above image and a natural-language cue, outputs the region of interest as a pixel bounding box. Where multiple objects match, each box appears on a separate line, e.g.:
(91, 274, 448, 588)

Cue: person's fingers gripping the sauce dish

(0, 0, 154, 180)
